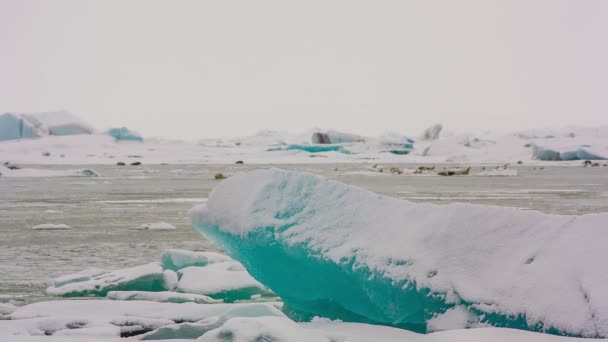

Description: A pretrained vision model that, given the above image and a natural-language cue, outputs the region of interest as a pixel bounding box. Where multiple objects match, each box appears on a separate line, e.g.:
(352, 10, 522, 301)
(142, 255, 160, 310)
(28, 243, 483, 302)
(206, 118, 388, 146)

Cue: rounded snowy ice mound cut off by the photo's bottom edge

(199, 317, 330, 342)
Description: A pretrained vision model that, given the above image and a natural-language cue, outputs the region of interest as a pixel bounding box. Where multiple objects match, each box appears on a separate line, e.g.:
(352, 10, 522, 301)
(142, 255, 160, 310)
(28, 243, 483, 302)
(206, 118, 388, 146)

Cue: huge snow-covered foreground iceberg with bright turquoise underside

(191, 169, 608, 337)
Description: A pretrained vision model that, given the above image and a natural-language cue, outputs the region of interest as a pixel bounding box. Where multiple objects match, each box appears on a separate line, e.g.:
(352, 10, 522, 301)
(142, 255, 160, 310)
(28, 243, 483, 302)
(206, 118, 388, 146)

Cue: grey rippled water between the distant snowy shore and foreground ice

(0, 164, 608, 302)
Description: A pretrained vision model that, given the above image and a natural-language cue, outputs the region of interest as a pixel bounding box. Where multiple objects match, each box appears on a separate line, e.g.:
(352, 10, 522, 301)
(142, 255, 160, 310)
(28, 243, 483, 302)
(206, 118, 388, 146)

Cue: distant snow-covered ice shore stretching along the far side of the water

(0, 126, 608, 165)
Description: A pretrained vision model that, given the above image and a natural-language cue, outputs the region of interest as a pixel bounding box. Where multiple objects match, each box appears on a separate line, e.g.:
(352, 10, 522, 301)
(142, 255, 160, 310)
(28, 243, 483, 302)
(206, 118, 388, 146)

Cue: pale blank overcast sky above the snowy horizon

(0, 0, 608, 138)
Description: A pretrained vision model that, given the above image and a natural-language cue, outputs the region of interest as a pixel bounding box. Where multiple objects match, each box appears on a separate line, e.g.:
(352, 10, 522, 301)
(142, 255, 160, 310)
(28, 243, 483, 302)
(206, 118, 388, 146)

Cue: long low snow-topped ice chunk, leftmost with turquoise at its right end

(46, 262, 172, 297)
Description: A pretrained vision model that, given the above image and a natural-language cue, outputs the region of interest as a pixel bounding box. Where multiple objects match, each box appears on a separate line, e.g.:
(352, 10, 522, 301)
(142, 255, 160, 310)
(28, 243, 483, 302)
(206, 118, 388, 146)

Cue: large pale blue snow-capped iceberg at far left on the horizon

(0, 111, 95, 141)
